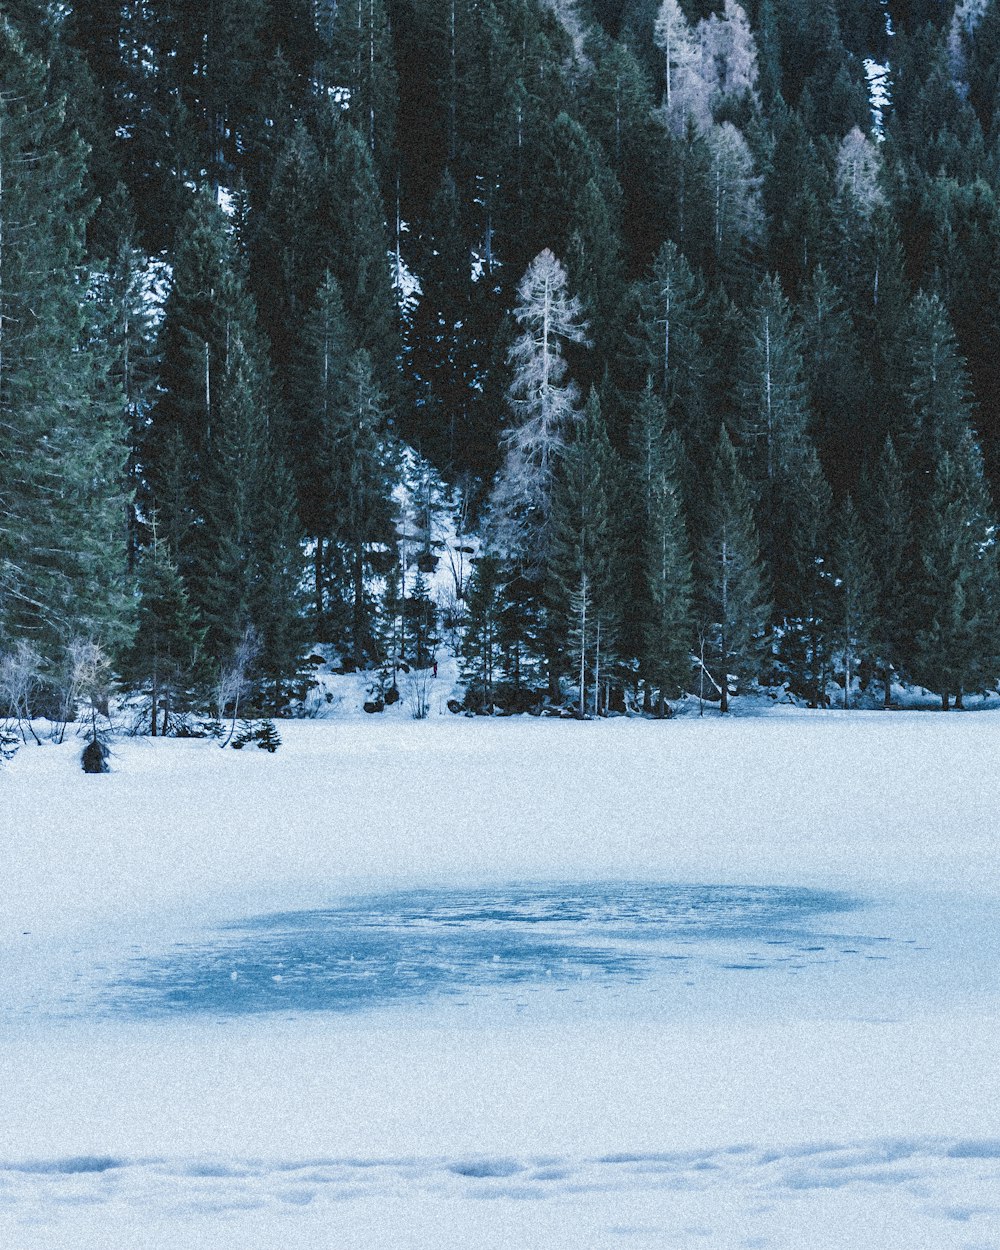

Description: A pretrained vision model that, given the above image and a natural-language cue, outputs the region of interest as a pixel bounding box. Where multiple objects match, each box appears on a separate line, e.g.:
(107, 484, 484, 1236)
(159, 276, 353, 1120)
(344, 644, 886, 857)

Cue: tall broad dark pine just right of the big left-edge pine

(146, 194, 300, 706)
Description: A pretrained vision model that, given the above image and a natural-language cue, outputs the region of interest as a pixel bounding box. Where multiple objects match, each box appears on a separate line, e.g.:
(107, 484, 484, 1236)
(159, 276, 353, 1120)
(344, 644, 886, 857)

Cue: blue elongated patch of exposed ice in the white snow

(95, 884, 891, 1016)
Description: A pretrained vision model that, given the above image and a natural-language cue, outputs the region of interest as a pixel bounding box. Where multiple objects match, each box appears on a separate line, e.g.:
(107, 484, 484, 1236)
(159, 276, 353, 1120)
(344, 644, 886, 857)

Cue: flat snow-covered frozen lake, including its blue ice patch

(0, 709, 1000, 1250)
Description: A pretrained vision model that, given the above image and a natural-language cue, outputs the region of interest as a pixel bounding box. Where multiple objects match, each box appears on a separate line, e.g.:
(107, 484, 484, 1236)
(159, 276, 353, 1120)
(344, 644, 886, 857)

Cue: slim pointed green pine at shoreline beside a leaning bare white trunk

(696, 429, 768, 713)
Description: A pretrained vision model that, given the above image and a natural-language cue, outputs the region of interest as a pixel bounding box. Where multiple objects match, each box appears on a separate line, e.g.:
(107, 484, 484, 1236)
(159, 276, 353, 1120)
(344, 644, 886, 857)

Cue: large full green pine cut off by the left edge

(0, 18, 134, 671)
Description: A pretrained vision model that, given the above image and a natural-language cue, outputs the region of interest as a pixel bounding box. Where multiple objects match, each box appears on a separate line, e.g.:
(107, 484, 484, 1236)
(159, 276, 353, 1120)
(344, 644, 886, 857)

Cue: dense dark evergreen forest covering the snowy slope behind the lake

(0, 0, 1000, 734)
